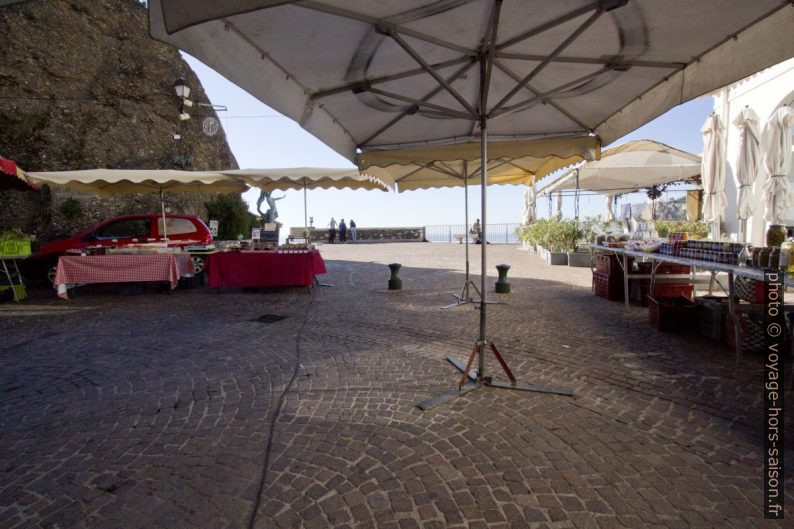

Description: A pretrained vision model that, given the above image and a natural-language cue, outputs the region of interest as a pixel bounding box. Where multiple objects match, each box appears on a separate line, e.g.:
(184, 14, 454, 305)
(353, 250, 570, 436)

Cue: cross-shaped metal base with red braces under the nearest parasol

(416, 344, 573, 411)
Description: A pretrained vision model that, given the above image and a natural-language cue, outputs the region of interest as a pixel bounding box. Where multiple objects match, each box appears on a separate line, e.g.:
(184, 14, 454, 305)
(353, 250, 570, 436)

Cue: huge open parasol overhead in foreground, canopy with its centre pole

(148, 0, 794, 410)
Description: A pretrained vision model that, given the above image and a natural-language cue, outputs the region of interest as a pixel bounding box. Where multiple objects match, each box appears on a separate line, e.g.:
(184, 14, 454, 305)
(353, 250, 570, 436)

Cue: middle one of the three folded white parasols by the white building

(733, 106, 761, 222)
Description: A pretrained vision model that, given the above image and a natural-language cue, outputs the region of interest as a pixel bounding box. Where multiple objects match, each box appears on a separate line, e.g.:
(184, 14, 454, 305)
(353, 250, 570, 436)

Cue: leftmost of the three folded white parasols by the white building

(700, 113, 727, 240)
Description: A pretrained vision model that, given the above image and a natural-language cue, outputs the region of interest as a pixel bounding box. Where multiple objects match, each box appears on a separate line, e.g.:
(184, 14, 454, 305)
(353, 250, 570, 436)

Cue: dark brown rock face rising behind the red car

(0, 0, 237, 239)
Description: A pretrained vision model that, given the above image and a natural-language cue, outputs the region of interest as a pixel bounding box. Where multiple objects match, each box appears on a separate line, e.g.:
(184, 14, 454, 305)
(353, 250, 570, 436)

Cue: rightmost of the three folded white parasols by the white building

(761, 106, 794, 224)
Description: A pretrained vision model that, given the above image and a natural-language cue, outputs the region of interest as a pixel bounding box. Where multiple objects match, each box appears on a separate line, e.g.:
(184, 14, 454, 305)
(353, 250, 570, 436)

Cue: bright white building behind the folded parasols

(711, 55, 794, 246)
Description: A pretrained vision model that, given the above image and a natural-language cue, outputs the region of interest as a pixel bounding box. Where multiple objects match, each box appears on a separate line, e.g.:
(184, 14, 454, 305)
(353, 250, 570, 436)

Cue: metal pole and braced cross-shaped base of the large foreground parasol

(417, 5, 573, 410)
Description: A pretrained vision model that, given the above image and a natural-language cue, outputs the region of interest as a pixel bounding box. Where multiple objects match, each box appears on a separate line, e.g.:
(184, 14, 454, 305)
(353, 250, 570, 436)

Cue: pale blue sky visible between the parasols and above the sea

(183, 54, 713, 233)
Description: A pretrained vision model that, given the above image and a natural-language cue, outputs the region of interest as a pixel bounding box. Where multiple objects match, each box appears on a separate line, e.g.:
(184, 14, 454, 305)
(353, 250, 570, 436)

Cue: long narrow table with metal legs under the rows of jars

(591, 245, 794, 360)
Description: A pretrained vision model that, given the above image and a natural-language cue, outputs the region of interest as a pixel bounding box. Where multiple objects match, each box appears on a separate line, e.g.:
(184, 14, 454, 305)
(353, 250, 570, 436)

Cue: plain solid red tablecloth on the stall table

(207, 250, 325, 288)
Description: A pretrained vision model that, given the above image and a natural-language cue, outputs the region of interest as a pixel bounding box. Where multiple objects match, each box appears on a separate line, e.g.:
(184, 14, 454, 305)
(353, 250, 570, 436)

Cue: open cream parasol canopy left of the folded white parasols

(541, 140, 701, 195)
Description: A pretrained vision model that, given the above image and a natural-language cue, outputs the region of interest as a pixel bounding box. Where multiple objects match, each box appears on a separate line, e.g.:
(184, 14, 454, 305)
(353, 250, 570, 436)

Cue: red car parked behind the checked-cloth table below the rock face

(29, 213, 214, 282)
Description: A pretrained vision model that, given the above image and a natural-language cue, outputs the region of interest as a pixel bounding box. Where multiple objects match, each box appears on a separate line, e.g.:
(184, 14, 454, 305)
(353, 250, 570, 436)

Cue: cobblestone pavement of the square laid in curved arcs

(0, 243, 794, 529)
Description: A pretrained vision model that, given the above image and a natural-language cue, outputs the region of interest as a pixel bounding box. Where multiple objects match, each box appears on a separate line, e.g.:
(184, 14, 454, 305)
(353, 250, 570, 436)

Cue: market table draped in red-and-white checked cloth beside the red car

(54, 254, 193, 299)
